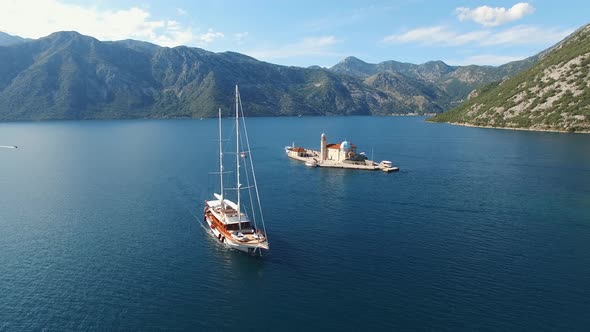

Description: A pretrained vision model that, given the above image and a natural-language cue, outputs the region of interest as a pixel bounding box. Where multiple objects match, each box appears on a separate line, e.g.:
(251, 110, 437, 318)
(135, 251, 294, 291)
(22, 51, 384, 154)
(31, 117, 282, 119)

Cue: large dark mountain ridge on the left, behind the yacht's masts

(0, 32, 412, 120)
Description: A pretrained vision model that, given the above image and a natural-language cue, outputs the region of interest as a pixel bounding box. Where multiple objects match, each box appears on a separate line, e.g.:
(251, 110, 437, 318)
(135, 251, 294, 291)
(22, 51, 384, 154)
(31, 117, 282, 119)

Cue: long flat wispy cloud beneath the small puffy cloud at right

(383, 25, 573, 46)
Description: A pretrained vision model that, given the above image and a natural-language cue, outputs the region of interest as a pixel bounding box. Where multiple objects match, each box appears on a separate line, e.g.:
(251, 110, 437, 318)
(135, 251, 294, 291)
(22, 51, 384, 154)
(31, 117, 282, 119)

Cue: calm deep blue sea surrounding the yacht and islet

(0, 117, 590, 331)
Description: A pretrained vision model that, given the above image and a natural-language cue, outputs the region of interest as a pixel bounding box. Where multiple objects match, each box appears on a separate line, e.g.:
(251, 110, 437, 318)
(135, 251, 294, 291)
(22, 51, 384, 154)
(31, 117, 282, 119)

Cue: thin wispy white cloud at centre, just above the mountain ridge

(246, 36, 338, 60)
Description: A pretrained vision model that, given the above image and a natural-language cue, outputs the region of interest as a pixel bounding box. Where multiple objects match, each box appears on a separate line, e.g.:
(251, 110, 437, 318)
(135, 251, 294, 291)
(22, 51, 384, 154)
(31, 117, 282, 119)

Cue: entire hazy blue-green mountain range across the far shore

(0, 32, 538, 120)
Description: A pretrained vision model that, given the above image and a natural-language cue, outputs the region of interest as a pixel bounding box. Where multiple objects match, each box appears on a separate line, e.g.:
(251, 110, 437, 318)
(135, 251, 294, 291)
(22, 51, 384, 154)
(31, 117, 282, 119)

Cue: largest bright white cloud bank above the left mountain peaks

(0, 0, 223, 46)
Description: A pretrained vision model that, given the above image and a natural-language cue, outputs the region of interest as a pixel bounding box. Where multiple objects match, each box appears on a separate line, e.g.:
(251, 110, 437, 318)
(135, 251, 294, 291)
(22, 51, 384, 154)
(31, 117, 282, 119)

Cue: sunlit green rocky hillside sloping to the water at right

(431, 24, 590, 132)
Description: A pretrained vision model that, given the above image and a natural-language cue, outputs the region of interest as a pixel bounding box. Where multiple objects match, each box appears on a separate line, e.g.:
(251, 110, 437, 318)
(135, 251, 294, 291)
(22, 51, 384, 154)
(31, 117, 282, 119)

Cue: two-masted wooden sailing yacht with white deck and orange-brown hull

(204, 85, 269, 254)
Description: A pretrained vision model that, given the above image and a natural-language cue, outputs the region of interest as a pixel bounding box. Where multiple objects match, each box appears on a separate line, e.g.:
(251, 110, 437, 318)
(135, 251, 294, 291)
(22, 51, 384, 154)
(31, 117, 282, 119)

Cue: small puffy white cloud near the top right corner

(455, 2, 535, 27)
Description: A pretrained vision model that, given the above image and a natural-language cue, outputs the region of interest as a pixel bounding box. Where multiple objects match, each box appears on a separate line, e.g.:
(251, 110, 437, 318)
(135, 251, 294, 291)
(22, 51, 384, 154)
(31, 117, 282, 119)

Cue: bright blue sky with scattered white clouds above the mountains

(0, 0, 590, 67)
